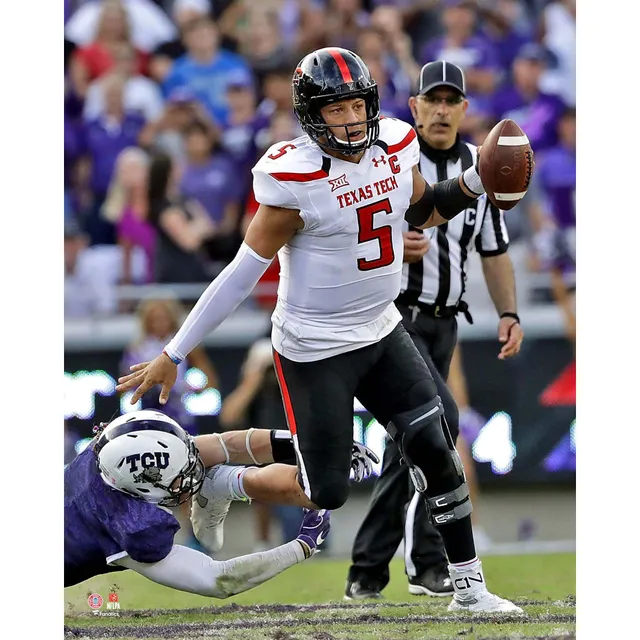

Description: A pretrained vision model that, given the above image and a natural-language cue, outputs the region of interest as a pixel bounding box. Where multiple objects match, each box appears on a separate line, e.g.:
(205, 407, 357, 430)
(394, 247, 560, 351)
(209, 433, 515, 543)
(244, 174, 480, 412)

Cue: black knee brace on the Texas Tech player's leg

(387, 396, 472, 525)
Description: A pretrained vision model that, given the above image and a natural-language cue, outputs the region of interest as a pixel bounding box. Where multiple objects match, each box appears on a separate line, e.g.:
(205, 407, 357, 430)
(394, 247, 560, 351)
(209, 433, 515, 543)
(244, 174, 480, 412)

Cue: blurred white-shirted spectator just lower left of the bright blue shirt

(84, 42, 164, 122)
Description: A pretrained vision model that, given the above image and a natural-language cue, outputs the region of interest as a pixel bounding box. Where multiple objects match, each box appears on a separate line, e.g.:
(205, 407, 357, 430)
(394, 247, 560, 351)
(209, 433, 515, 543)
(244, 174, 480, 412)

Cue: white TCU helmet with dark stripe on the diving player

(94, 410, 204, 507)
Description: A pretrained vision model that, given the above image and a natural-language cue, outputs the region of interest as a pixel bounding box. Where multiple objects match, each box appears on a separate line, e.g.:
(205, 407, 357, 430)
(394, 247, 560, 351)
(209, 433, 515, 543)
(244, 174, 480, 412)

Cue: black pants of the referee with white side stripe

(347, 303, 458, 589)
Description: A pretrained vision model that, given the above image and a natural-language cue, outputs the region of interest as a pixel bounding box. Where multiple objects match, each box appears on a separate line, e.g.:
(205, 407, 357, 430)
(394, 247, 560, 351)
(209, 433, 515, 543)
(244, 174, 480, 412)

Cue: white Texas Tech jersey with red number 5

(253, 118, 420, 362)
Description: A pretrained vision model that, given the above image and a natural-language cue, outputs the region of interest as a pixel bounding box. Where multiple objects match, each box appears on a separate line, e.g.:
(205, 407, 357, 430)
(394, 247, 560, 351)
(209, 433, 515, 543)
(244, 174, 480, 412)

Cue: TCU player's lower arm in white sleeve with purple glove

(114, 511, 331, 598)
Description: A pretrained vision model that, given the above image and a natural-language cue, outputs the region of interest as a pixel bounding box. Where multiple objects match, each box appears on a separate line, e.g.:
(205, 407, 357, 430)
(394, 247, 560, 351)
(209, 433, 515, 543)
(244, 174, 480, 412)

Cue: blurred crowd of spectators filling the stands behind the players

(64, 0, 576, 317)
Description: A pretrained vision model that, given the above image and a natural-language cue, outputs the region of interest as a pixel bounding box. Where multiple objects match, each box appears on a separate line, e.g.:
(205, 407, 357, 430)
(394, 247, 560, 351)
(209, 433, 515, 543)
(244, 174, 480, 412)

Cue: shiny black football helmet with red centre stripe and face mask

(292, 47, 380, 155)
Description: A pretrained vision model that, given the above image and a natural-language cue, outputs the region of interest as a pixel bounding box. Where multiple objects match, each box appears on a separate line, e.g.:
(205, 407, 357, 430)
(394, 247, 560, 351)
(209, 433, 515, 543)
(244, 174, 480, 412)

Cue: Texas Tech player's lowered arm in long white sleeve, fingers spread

(116, 205, 303, 404)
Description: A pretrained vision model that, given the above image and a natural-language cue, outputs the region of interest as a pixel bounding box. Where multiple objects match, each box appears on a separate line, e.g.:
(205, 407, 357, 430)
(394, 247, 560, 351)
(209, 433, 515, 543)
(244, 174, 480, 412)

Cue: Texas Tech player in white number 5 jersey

(117, 48, 522, 613)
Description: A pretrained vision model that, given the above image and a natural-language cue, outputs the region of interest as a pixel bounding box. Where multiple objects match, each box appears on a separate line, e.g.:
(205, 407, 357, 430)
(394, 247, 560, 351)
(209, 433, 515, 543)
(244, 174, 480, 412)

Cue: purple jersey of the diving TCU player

(64, 441, 180, 587)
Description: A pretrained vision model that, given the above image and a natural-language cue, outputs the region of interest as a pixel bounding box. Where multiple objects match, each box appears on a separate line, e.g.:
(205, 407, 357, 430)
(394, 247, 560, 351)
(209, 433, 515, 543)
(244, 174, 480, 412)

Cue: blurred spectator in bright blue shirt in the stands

(163, 17, 253, 123)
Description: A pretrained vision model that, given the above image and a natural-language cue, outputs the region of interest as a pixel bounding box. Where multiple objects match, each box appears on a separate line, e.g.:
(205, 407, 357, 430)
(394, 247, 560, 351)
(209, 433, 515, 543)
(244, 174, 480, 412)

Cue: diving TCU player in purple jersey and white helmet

(64, 410, 377, 598)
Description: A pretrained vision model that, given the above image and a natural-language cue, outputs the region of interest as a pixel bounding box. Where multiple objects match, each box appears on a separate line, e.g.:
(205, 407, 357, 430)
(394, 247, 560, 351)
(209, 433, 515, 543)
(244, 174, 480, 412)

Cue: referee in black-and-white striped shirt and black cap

(345, 61, 523, 600)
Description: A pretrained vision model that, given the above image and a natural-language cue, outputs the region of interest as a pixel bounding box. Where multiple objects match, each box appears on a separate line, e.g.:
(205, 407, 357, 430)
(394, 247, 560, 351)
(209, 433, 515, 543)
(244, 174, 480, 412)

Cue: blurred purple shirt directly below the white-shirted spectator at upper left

(83, 112, 145, 195)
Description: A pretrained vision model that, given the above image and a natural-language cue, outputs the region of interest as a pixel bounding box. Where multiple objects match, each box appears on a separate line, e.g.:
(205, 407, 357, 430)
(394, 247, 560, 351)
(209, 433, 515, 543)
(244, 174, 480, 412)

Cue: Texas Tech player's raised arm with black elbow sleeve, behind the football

(404, 165, 484, 229)
